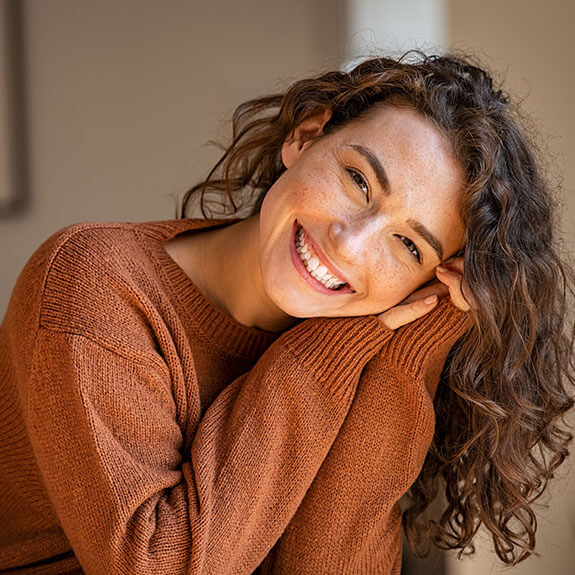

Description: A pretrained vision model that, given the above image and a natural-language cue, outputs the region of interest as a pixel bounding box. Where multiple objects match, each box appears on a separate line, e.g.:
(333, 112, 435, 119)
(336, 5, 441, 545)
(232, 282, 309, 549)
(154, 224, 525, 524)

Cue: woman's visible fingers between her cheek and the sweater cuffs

(378, 257, 471, 330)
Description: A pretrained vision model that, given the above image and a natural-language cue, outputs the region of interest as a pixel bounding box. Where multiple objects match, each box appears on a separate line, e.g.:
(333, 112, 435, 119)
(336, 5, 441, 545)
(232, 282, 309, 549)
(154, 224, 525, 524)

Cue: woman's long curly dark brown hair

(180, 52, 575, 564)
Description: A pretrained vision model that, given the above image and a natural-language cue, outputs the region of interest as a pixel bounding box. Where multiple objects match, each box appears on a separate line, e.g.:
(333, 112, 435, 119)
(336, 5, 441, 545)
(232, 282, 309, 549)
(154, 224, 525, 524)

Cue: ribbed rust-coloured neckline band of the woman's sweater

(141, 219, 280, 361)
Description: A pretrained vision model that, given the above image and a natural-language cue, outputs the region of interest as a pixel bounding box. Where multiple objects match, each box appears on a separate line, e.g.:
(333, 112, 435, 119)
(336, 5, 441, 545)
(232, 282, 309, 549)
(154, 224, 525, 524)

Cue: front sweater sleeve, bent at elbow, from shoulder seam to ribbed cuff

(25, 317, 392, 575)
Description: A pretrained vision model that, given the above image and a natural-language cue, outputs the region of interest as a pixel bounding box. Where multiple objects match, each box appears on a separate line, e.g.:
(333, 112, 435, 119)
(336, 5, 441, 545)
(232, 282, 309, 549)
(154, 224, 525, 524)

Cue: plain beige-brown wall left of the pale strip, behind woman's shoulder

(0, 0, 342, 316)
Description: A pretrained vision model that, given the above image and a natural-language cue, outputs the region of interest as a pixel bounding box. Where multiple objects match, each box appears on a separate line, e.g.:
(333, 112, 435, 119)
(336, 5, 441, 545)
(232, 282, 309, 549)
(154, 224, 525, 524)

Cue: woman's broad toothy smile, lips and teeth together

(292, 222, 353, 294)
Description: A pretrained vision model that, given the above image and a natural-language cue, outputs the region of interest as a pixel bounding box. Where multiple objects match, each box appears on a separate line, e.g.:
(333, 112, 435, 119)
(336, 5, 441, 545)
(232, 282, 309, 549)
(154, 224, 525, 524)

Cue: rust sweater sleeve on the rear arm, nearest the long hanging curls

(254, 301, 470, 575)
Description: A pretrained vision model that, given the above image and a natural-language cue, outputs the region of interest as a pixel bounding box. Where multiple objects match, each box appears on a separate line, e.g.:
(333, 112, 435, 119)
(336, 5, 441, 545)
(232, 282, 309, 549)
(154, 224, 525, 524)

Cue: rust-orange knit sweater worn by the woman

(0, 220, 468, 575)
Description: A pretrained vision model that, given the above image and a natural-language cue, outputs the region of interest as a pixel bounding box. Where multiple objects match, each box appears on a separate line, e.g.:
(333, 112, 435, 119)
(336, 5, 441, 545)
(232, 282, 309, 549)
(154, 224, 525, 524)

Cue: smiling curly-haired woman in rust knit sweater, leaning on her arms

(0, 56, 574, 574)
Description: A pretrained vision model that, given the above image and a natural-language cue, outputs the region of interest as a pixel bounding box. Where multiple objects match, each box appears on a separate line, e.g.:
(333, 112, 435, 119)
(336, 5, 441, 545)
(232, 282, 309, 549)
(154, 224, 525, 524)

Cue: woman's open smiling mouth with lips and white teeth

(290, 220, 354, 295)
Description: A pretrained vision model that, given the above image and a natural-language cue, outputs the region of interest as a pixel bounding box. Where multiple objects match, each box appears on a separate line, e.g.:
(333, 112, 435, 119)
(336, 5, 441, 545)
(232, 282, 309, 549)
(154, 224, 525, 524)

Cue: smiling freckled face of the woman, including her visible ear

(259, 105, 464, 318)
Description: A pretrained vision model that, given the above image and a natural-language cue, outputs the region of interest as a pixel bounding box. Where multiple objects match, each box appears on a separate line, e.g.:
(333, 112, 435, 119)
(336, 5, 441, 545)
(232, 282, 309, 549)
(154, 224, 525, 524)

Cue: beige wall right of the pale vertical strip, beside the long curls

(449, 0, 575, 575)
